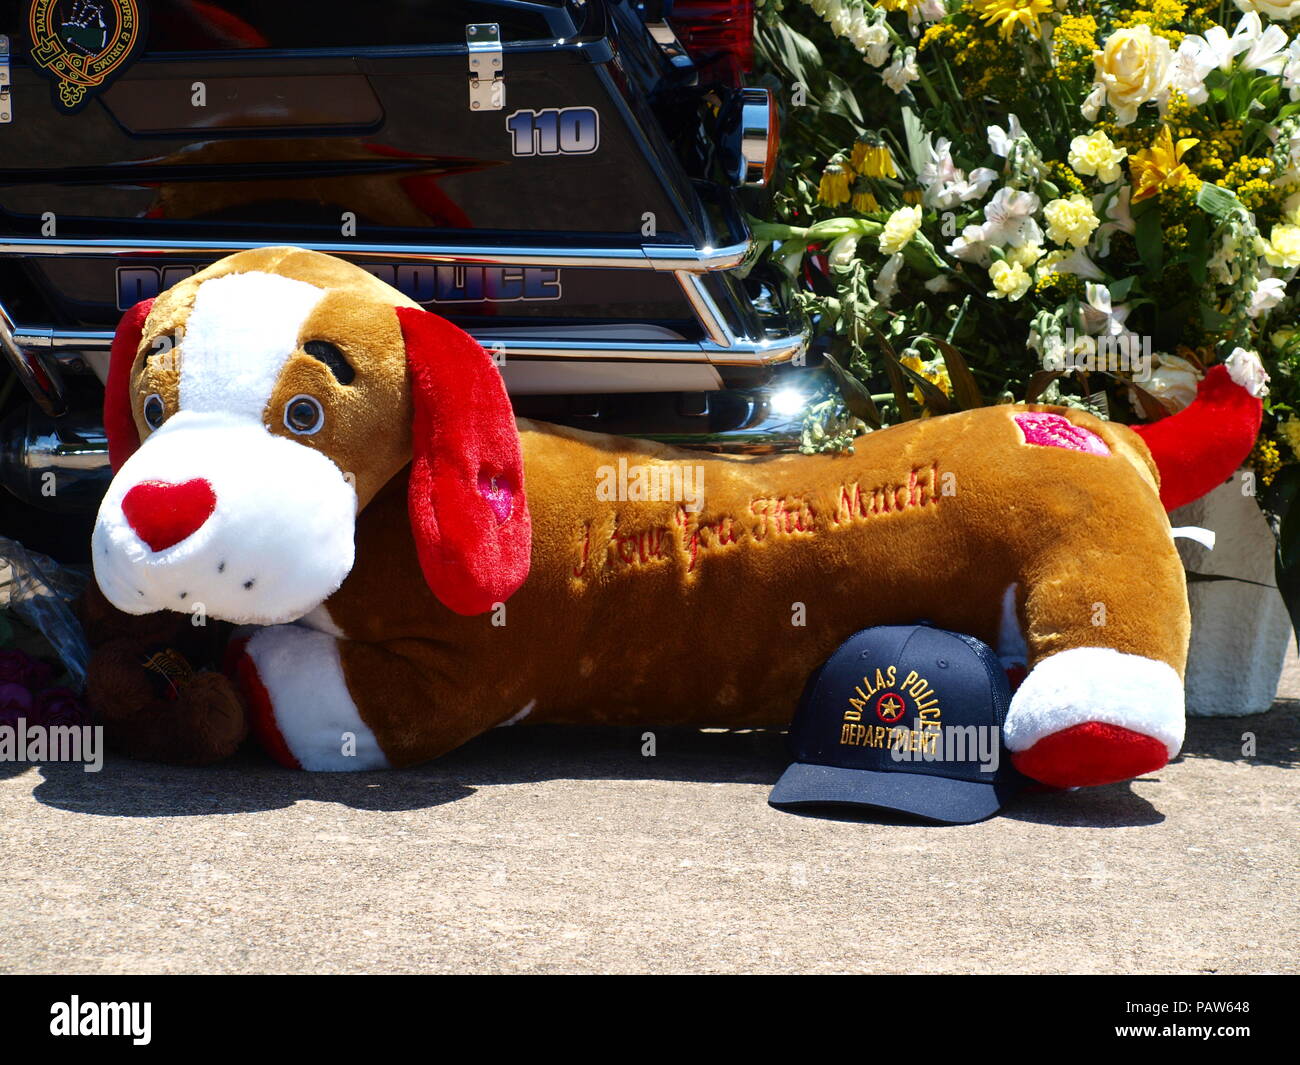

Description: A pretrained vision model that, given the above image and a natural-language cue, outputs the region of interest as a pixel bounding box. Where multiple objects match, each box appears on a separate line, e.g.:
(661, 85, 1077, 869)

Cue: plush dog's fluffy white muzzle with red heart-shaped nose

(92, 411, 356, 624)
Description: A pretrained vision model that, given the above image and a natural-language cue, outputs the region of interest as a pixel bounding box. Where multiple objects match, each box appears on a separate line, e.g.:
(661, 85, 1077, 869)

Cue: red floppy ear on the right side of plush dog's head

(397, 307, 533, 614)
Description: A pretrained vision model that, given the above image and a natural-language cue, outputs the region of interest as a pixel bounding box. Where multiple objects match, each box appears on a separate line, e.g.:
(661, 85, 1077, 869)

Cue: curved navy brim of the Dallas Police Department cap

(767, 762, 1017, 824)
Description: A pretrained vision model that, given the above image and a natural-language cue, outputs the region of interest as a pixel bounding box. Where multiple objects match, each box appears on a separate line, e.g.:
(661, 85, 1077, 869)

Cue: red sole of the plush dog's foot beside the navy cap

(1011, 722, 1169, 788)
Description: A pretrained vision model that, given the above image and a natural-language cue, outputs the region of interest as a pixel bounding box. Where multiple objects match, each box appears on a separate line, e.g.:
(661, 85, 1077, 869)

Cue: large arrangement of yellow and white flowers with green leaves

(755, 0, 1300, 631)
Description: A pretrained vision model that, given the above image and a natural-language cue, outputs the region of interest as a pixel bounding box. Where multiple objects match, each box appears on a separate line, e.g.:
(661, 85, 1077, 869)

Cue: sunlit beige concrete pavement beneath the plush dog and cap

(0, 670, 1300, 973)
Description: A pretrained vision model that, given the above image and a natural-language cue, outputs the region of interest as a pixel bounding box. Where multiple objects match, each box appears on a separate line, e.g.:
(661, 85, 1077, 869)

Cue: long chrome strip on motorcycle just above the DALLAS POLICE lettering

(0, 237, 753, 273)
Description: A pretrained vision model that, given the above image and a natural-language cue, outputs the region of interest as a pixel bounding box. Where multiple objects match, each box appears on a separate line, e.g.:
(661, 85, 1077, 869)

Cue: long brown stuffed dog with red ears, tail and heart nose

(92, 247, 1260, 787)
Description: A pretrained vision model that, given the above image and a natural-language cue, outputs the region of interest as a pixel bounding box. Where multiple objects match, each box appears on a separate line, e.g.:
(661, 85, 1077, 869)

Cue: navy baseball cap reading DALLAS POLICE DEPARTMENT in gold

(767, 624, 1024, 824)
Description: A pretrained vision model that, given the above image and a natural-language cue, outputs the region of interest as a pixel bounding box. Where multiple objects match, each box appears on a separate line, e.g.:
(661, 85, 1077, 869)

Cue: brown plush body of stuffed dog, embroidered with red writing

(328, 407, 1188, 765)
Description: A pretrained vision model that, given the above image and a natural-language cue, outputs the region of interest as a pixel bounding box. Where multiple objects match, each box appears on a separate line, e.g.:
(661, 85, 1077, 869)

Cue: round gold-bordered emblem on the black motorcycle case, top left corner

(27, 0, 144, 114)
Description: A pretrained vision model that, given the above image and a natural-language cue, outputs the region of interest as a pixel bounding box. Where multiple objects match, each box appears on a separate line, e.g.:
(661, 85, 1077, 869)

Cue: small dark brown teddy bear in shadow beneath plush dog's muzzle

(79, 583, 248, 766)
